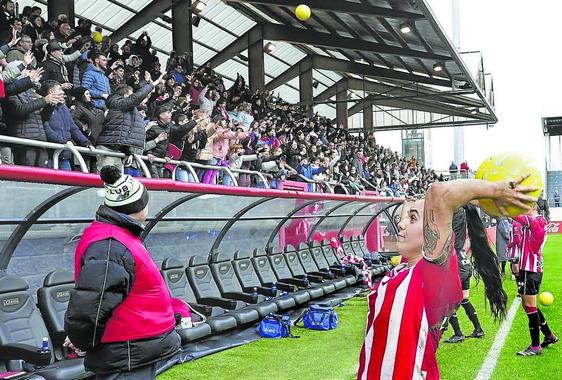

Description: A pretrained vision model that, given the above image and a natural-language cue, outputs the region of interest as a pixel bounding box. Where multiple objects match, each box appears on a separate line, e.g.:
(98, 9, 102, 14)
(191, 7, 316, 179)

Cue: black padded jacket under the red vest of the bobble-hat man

(64, 205, 180, 374)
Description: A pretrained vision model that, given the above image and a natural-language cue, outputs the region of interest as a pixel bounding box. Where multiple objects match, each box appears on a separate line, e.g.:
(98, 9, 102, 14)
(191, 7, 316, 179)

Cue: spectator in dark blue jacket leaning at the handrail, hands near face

(40, 80, 93, 171)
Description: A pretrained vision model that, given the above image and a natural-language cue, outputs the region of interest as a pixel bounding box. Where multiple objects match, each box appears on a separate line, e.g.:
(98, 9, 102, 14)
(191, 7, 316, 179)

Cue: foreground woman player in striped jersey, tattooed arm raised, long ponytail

(358, 177, 536, 380)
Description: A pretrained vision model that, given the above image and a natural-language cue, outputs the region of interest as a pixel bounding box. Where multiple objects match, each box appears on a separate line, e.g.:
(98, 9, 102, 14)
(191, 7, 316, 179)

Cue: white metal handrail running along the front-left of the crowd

(0, 135, 269, 187)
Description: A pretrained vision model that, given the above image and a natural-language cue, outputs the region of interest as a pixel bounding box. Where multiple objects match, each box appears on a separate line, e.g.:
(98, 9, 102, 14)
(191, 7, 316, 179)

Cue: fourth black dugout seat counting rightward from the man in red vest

(232, 251, 296, 310)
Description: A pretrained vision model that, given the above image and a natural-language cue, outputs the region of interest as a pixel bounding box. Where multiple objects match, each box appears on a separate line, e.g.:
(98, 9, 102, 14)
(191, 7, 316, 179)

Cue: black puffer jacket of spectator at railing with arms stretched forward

(97, 84, 154, 150)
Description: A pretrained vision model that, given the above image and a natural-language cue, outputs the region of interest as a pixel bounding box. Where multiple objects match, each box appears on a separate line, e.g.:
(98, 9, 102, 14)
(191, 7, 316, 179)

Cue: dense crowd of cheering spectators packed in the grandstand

(0, 0, 443, 196)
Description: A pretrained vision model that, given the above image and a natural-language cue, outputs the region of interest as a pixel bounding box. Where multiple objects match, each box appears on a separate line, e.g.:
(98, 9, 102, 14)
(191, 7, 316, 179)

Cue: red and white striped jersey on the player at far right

(514, 214, 548, 272)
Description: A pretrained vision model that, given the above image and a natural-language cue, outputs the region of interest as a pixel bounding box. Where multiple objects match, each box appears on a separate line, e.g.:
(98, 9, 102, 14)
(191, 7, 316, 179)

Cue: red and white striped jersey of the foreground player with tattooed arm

(357, 253, 462, 380)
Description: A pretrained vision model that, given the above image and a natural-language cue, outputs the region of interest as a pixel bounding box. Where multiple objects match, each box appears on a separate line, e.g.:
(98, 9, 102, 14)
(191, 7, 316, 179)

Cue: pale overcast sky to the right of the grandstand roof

(372, 0, 562, 170)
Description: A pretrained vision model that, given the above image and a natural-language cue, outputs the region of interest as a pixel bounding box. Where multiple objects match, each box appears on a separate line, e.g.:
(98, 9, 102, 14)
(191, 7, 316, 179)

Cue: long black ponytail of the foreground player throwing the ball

(464, 204, 507, 320)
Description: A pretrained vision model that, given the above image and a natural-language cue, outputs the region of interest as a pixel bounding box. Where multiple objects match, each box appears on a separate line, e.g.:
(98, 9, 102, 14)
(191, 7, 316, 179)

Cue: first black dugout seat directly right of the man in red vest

(161, 258, 238, 336)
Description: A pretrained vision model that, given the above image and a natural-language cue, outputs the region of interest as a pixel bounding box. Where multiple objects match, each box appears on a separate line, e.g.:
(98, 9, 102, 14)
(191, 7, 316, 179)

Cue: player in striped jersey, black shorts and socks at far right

(513, 206, 558, 356)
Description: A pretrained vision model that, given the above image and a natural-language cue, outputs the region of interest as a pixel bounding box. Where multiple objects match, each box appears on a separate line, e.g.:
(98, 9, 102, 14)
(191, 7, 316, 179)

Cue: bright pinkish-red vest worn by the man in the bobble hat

(74, 221, 175, 343)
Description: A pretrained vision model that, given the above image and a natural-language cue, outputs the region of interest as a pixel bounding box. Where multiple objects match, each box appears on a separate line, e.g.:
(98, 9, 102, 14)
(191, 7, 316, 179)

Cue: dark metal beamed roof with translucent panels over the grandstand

(20, 0, 497, 130)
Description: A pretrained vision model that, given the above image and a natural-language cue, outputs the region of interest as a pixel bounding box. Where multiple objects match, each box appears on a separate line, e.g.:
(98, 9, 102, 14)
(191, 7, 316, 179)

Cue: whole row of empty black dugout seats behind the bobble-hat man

(0, 239, 389, 380)
